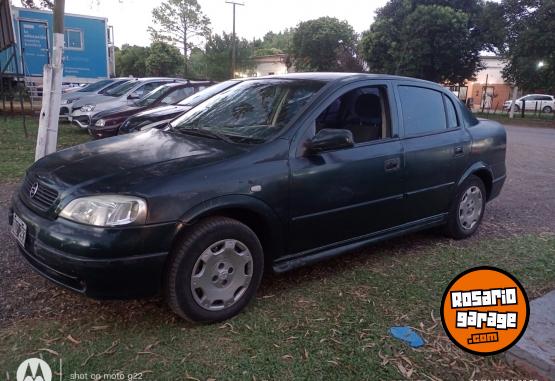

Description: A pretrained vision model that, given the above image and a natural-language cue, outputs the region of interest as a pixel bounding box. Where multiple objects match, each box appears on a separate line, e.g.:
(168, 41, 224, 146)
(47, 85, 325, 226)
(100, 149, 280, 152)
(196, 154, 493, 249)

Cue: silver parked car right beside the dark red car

(69, 78, 184, 128)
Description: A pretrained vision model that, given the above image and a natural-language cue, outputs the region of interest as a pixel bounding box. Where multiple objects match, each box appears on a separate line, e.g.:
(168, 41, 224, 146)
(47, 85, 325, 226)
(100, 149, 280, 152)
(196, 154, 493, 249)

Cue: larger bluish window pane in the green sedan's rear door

(399, 86, 447, 135)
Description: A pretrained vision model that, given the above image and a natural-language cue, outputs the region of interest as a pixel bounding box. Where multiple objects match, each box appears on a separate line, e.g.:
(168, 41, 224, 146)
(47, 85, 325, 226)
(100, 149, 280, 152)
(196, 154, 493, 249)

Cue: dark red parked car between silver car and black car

(88, 81, 212, 139)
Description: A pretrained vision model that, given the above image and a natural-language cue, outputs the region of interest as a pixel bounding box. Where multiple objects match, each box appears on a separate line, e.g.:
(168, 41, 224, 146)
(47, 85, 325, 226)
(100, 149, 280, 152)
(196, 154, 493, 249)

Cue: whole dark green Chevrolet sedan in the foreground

(9, 73, 506, 321)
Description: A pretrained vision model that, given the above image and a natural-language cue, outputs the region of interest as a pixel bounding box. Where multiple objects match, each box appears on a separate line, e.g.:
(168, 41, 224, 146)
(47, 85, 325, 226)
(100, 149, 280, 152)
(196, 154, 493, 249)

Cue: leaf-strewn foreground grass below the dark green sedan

(0, 234, 555, 380)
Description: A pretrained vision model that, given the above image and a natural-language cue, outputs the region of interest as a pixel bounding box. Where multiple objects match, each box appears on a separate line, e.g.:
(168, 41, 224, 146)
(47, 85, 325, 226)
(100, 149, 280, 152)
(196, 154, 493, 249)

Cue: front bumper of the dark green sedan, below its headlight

(9, 196, 177, 299)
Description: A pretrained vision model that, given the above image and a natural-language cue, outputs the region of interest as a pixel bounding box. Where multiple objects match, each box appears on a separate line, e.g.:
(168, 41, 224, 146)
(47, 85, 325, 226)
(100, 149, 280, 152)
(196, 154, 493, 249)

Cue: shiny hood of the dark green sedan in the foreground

(29, 130, 246, 196)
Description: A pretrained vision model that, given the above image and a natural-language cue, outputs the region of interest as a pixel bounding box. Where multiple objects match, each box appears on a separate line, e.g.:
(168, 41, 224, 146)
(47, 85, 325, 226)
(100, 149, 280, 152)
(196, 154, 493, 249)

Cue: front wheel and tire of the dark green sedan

(164, 217, 264, 323)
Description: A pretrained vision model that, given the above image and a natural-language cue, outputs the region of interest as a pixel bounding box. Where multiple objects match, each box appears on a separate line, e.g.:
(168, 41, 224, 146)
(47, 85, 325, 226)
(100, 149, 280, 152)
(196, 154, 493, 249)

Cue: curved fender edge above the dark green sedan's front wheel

(174, 195, 285, 268)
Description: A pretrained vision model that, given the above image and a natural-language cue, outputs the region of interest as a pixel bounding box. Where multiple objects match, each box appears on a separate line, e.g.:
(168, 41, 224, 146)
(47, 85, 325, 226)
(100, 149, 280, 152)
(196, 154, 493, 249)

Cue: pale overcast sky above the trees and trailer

(13, 0, 387, 46)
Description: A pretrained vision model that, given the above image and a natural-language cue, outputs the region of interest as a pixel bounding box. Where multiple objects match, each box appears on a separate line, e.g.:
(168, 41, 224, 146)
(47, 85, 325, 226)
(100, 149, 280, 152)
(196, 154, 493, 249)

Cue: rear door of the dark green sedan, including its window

(396, 82, 471, 221)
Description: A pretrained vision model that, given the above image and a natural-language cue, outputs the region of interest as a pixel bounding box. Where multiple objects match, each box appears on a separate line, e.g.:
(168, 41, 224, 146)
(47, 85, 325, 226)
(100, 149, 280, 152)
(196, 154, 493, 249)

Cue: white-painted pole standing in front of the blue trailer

(35, 0, 65, 161)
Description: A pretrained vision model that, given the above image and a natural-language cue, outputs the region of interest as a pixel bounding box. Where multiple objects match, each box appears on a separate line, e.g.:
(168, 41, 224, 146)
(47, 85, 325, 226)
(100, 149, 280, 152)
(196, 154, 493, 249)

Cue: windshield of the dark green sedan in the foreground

(171, 79, 323, 143)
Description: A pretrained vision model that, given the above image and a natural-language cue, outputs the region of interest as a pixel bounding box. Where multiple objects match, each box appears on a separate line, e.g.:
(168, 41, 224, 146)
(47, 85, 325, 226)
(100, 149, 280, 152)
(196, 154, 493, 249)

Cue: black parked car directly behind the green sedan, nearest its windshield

(118, 79, 239, 135)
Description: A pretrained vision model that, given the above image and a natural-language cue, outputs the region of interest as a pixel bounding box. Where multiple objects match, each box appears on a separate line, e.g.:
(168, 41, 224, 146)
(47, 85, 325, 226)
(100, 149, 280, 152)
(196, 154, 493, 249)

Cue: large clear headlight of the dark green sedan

(60, 195, 147, 226)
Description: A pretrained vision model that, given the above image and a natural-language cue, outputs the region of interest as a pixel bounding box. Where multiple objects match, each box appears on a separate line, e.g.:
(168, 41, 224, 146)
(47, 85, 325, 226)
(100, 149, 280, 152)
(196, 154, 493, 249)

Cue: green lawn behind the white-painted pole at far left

(0, 116, 90, 182)
